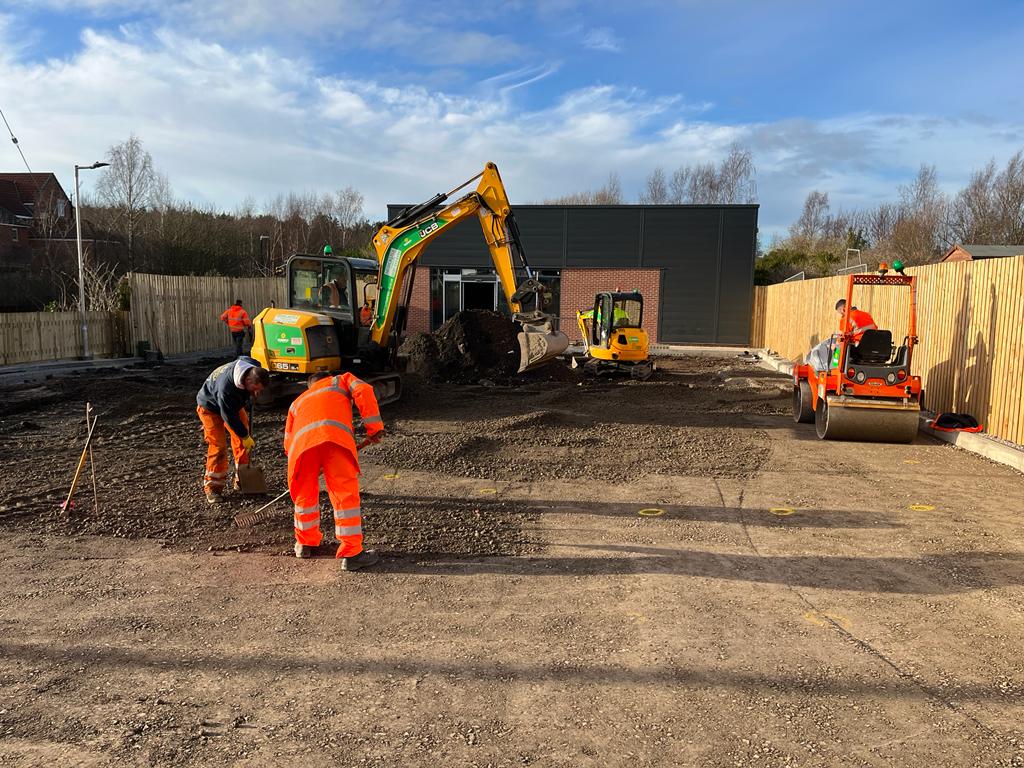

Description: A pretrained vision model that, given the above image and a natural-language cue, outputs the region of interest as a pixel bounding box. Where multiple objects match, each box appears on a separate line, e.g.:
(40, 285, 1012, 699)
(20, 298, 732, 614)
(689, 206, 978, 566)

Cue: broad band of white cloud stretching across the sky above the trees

(0, 24, 1024, 240)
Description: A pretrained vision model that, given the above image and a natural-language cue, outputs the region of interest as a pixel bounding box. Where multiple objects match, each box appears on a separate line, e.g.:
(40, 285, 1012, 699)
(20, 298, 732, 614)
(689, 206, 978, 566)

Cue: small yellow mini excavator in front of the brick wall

(572, 291, 654, 381)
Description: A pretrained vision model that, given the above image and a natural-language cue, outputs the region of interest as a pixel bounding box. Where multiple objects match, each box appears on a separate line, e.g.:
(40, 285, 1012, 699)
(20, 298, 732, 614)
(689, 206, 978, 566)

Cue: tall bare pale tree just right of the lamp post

(96, 134, 158, 269)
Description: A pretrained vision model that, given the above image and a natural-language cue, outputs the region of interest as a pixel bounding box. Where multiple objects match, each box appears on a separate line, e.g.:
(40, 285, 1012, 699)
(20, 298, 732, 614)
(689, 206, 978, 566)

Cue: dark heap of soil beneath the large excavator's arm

(398, 309, 519, 384)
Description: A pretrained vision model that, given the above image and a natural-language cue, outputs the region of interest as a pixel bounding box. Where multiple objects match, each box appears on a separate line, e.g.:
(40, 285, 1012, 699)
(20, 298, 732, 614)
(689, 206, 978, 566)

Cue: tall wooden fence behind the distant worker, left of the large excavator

(128, 273, 287, 354)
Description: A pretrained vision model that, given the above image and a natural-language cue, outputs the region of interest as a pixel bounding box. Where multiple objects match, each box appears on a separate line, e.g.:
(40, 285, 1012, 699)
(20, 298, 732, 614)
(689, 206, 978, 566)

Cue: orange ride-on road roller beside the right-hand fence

(793, 262, 922, 442)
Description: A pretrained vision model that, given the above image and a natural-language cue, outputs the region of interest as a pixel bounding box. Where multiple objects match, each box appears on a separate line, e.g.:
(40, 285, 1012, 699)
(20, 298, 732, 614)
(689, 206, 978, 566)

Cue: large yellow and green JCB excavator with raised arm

(251, 163, 568, 404)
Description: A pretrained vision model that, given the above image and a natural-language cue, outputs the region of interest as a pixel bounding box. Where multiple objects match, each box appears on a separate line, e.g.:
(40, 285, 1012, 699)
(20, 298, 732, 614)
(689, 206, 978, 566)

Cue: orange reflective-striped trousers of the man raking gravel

(288, 442, 362, 557)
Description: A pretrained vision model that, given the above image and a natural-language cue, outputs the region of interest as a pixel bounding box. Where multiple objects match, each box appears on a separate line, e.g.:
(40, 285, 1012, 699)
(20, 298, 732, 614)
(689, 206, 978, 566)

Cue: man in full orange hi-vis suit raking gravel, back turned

(285, 373, 384, 570)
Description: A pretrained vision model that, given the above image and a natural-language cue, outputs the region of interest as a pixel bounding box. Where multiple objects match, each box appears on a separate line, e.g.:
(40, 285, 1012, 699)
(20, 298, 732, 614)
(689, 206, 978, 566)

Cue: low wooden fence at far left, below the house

(0, 312, 126, 366)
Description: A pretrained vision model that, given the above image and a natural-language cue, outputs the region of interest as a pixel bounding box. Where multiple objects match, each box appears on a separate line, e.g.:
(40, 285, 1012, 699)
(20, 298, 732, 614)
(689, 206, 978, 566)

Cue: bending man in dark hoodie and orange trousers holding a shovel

(196, 357, 270, 504)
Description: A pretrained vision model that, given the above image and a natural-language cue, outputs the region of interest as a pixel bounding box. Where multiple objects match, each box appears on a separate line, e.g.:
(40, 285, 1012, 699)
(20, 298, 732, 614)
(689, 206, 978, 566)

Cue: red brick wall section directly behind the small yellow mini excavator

(560, 268, 662, 343)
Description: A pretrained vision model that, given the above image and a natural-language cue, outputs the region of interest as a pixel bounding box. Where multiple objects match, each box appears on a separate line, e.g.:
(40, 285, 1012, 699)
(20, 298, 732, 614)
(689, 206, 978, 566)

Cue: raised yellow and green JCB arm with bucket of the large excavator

(371, 163, 568, 371)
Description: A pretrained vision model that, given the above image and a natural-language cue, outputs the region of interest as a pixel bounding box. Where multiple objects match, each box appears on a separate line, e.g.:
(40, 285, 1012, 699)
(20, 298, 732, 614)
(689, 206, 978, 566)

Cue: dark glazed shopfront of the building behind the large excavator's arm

(430, 267, 561, 330)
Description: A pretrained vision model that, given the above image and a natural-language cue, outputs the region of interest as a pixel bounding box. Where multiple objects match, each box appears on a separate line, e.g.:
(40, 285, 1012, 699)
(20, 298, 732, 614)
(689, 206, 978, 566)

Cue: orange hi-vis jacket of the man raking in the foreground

(285, 374, 384, 483)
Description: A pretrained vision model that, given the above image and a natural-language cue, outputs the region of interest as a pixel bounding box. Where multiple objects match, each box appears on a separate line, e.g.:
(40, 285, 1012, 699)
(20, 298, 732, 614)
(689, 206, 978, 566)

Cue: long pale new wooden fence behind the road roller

(752, 256, 1024, 443)
